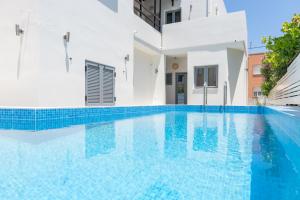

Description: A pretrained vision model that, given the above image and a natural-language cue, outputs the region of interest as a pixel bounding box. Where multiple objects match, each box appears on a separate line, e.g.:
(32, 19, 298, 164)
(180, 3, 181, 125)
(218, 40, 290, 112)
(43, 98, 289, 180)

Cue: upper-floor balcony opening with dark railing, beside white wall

(133, 0, 161, 31)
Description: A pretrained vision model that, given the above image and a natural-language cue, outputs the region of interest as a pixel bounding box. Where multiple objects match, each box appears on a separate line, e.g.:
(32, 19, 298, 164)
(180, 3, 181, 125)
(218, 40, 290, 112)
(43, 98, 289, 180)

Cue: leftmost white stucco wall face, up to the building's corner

(0, 0, 40, 106)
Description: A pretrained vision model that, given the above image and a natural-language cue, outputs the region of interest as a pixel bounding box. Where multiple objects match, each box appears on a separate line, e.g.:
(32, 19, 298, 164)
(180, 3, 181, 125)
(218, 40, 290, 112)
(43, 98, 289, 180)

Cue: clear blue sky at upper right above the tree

(224, 0, 300, 52)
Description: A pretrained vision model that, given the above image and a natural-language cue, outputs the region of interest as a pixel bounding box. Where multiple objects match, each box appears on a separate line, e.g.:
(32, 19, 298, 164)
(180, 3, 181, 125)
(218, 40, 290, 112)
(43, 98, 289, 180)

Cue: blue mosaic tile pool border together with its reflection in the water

(0, 105, 264, 131)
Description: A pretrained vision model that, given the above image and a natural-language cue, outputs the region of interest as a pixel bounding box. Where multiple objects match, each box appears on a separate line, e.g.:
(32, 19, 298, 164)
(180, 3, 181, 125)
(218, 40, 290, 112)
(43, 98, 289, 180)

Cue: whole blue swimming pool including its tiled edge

(0, 106, 300, 200)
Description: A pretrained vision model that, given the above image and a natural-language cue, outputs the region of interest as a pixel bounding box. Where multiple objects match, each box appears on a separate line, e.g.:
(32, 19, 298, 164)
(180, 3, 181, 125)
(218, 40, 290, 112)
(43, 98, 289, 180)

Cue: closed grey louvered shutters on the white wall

(85, 61, 115, 106)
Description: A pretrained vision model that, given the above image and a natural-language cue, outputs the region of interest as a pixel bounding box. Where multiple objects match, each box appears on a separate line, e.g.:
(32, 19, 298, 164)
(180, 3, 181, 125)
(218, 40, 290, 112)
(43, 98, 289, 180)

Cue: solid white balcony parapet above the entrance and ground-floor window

(162, 12, 247, 51)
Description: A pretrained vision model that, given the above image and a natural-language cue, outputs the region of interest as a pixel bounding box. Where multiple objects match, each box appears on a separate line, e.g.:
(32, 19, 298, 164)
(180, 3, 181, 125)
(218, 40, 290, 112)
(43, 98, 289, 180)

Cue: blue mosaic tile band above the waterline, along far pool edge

(0, 105, 264, 120)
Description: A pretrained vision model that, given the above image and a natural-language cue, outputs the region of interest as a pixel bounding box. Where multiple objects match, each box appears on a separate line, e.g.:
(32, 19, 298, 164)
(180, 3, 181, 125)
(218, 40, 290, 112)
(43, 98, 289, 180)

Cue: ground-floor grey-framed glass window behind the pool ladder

(194, 66, 218, 87)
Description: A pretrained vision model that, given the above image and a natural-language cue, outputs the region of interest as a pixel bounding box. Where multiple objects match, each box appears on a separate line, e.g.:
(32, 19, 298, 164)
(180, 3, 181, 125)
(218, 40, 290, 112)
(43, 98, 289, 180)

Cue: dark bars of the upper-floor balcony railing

(134, 0, 161, 31)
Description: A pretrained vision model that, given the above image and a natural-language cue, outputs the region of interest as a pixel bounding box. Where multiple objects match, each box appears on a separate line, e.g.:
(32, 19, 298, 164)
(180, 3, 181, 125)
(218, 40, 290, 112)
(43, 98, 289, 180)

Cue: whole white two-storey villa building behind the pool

(0, 0, 247, 107)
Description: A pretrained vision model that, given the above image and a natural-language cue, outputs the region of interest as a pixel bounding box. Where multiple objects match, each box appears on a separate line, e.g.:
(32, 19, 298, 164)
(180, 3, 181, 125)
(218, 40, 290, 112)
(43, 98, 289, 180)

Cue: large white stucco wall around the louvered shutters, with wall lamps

(0, 0, 165, 107)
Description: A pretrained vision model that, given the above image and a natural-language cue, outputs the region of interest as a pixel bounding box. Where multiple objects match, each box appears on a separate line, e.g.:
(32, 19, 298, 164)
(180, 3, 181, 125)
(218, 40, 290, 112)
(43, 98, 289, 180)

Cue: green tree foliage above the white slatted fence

(262, 14, 300, 96)
